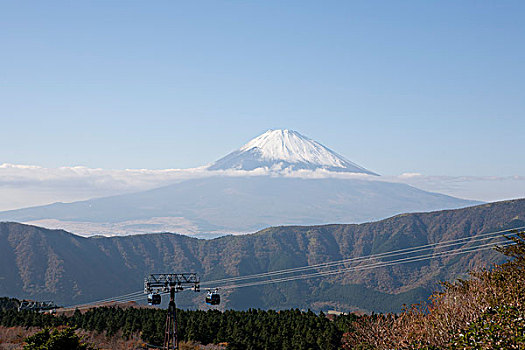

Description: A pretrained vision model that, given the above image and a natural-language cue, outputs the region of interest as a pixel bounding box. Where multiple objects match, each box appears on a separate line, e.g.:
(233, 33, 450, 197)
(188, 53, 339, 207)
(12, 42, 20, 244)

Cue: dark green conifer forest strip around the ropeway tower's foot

(0, 298, 357, 350)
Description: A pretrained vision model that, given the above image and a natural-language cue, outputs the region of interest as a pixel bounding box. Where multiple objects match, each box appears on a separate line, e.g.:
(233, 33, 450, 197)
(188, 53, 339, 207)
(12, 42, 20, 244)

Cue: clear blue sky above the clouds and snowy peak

(0, 1, 525, 176)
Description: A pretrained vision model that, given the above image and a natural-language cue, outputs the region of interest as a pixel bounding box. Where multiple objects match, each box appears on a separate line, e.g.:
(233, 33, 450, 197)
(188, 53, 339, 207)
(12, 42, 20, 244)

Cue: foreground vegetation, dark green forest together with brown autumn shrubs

(0, 230, 525, 350)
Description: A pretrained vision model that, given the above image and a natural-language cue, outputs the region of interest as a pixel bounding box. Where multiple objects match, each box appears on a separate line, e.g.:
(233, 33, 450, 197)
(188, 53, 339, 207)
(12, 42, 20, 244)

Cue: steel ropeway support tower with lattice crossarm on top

(144, 273, 200, 350)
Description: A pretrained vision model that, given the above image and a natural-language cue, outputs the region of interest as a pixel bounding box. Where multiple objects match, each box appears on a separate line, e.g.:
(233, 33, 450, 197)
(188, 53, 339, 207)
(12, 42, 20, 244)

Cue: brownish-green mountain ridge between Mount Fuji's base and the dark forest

(0, 200, 525, 311)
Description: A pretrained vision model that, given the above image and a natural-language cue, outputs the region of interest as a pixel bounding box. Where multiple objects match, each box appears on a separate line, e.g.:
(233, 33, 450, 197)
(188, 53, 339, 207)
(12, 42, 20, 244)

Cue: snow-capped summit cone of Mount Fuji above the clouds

(208, 129, 377, 175)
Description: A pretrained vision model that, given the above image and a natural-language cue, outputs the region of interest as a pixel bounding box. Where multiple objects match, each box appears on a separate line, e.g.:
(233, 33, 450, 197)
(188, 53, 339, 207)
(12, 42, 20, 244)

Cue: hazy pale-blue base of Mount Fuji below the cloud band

(0, 176, 480, 238)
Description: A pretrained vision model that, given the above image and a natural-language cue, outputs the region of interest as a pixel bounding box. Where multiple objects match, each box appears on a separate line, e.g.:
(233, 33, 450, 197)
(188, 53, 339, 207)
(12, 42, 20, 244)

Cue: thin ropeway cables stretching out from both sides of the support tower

(60, 226, 525, 309)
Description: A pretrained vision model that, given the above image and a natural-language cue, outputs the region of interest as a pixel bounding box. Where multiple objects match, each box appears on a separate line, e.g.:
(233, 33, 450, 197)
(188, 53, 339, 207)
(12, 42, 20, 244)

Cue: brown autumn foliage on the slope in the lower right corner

(343, 231, 525, 349)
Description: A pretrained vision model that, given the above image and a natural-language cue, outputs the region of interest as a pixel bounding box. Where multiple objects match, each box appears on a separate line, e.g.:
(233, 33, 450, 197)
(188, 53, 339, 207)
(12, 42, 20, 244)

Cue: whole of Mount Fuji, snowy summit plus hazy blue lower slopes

(0, 130, 480, 238)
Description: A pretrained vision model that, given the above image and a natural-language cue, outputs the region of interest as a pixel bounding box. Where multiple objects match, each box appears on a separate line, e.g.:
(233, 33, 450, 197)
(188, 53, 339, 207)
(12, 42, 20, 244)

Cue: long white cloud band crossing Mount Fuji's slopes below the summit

(0, 163, 525, 210)
